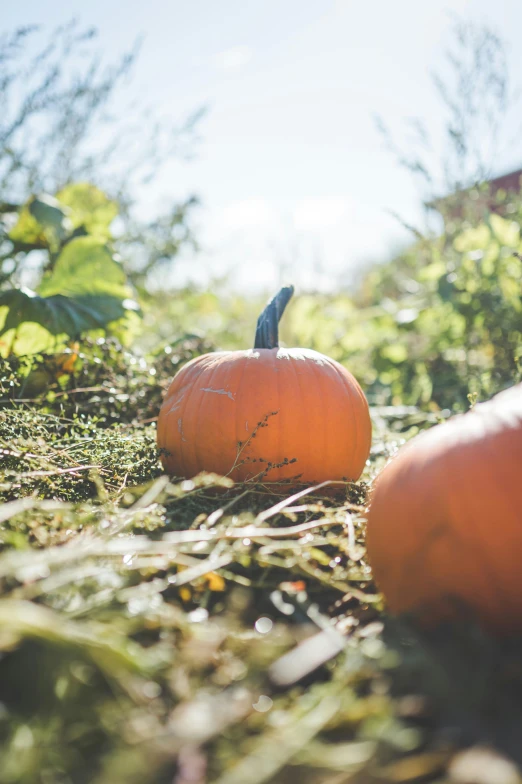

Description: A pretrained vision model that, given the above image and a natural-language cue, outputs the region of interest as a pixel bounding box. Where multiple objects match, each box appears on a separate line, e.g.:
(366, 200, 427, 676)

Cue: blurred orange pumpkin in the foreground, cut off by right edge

(367, 384, 522, 632)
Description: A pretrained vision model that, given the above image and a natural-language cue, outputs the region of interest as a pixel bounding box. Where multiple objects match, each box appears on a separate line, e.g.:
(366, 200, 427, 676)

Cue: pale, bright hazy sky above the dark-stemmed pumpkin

(0, 0, 522, 288)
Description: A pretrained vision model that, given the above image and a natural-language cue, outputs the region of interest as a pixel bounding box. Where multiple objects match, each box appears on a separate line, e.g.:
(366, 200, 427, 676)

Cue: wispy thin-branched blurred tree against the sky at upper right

(376, 18, 519, 219)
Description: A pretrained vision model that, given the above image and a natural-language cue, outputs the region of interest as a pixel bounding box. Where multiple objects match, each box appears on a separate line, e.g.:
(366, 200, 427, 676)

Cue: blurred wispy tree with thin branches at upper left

(0, 20, 204, 284)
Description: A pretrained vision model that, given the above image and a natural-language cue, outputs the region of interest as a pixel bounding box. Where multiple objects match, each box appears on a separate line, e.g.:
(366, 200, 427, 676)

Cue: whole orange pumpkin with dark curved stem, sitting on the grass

(157, 286, 371, 484)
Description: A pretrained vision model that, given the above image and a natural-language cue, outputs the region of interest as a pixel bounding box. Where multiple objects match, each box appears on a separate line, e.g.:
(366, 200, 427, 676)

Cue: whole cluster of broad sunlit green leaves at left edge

(0, 183, 139, 356)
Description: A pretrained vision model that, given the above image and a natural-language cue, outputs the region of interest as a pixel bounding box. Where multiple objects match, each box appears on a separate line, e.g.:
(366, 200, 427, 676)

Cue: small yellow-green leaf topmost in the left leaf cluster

(56, 182, 118, 239)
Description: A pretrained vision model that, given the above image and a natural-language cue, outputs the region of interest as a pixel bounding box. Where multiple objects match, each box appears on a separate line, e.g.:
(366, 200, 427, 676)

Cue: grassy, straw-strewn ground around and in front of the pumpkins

(0, 338, 522, 784)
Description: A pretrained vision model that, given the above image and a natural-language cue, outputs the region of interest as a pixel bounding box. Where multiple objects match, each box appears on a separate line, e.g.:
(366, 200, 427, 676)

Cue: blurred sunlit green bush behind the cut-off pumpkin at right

(346, 197, 522, 410)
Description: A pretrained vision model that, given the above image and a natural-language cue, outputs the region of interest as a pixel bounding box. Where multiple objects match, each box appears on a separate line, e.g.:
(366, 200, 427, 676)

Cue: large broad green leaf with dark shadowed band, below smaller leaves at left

(0, 237, 138, 355)
